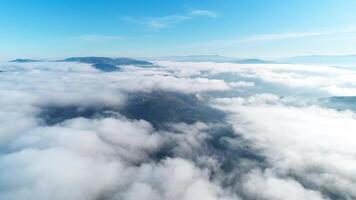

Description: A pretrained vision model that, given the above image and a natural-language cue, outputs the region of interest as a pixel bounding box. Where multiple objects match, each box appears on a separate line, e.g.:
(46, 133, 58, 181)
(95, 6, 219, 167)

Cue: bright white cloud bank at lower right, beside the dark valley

(214, 96, 356, 199)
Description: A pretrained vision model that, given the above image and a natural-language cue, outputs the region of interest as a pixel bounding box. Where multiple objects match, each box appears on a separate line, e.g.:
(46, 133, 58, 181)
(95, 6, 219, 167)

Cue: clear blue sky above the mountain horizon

(0, 0, 356, 58)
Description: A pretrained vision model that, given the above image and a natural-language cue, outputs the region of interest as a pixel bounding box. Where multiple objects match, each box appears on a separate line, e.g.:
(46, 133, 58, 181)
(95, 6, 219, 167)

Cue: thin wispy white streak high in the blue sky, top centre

(124, 9, 218, 30)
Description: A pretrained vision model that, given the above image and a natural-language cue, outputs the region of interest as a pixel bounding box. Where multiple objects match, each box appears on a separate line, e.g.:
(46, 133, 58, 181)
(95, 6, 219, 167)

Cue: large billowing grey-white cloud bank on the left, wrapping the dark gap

(0, 62, 239, 200)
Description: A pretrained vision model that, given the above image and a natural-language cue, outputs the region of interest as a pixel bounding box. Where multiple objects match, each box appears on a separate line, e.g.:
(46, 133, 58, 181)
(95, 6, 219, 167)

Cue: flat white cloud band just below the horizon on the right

(157, 61, 356, 96)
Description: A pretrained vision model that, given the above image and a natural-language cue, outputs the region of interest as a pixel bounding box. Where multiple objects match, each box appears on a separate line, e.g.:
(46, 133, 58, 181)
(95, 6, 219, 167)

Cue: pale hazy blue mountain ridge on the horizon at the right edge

(278, 55, 356, 66)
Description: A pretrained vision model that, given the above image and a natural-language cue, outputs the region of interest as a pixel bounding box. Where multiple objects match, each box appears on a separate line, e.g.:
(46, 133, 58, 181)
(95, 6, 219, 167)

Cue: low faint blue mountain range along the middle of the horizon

(154, 55, 273, 64)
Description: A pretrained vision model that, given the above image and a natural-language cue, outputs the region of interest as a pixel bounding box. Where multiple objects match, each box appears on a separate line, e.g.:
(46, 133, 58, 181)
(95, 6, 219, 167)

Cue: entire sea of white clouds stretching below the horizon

(0, 61, 356, 200)
